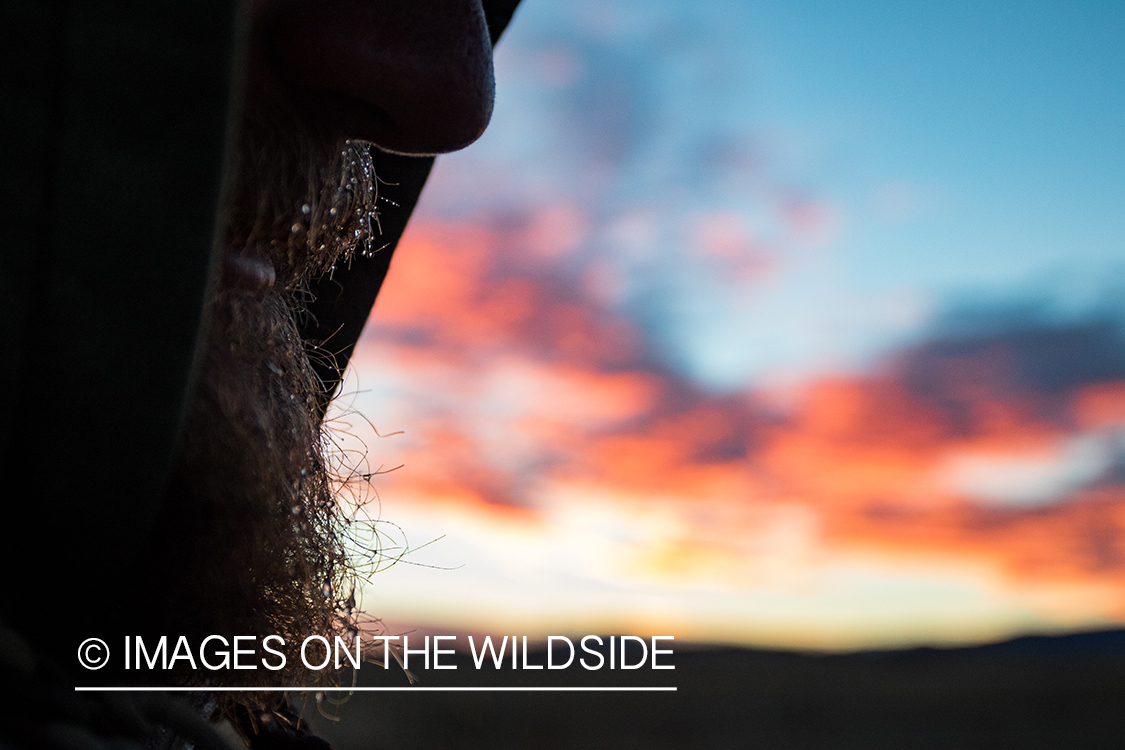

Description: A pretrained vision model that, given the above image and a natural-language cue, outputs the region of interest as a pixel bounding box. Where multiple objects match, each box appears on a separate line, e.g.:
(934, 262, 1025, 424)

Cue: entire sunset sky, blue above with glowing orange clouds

(330, 0, 1125, 650)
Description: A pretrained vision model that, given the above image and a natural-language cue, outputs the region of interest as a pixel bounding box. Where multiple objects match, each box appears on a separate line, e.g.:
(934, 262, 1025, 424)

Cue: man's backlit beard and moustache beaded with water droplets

(139, 105, 377, 692)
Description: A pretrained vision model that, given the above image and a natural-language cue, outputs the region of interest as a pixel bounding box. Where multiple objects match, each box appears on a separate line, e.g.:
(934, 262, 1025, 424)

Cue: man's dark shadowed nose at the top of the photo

(262, 0, 495, 154)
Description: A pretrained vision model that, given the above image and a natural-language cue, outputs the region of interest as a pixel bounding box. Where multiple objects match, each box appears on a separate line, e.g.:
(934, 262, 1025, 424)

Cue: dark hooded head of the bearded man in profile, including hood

(0, 0, 515, 715)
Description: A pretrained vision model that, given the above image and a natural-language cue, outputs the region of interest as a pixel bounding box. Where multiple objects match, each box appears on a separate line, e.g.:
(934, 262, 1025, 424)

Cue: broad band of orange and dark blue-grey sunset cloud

(339, 219, 1125, 634)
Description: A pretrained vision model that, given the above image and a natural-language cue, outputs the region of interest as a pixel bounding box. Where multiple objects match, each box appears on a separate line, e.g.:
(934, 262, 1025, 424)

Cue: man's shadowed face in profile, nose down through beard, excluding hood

(146, 0, 506, 692)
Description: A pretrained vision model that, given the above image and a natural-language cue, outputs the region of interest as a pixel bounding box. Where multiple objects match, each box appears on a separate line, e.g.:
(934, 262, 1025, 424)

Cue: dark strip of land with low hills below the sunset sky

(297, 631, 1125, 750)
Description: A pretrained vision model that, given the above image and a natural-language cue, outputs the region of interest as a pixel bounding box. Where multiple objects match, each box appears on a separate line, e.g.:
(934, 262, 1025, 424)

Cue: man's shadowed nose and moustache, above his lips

(224, 0, 494, 283)
